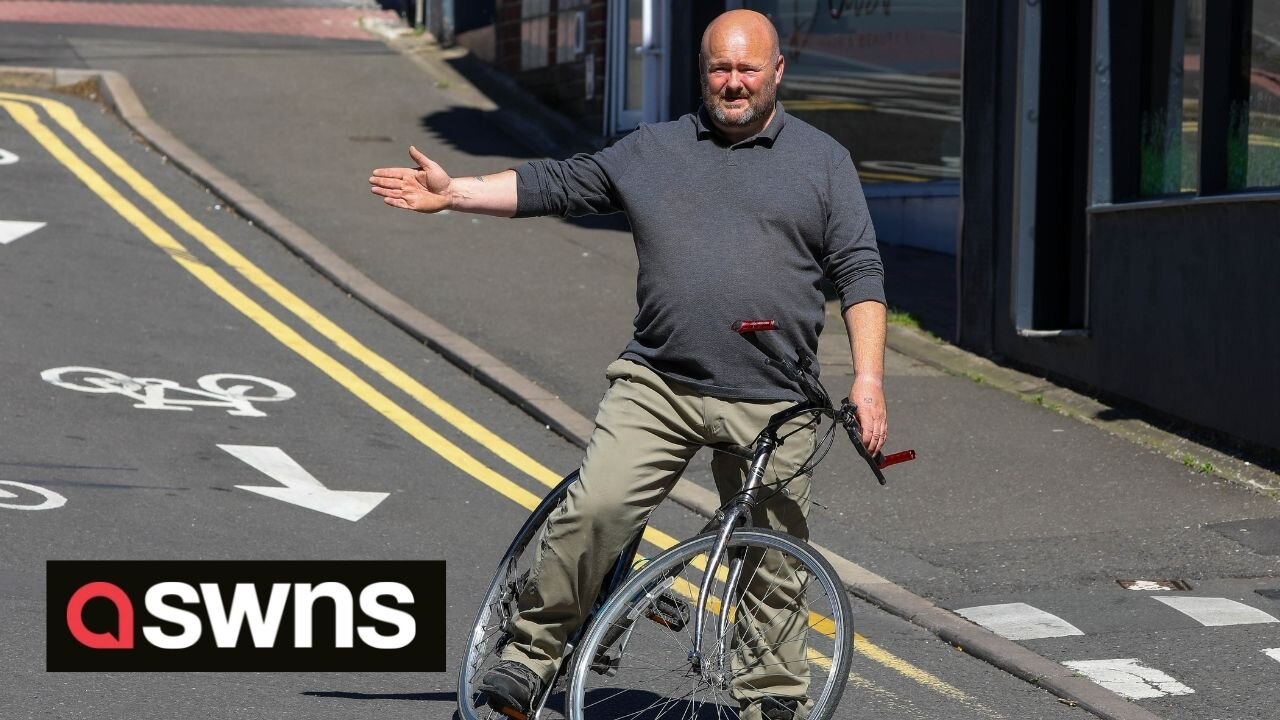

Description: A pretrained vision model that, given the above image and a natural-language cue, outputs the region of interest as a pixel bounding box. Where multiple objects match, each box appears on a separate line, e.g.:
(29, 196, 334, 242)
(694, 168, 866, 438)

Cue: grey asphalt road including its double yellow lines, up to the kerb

(0, 87, 1085, 719)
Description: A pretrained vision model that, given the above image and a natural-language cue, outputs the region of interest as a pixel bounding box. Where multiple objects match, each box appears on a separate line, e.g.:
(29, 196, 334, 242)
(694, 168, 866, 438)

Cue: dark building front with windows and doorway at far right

(957, 0, 1280, 451)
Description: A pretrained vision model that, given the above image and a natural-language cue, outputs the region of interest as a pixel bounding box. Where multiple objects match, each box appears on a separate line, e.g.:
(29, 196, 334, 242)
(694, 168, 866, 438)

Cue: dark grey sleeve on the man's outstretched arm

(516, 131, 641, 218)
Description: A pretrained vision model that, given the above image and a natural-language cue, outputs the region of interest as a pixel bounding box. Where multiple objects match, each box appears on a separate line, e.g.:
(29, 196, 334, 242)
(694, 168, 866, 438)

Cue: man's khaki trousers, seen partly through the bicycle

(503, 360, 815, 715)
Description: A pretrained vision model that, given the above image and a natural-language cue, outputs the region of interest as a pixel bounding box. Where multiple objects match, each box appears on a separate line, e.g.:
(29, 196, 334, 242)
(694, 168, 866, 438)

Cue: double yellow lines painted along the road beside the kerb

(0, 92, 973, 702)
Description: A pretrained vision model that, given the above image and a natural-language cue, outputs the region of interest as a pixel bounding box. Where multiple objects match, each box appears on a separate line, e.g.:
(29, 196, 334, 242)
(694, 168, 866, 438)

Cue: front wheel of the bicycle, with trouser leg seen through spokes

(566, 529, 854, 720)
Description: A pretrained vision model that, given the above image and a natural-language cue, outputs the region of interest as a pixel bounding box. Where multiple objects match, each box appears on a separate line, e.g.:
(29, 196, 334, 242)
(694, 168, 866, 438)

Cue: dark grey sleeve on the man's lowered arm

(823, 154, 886, 314)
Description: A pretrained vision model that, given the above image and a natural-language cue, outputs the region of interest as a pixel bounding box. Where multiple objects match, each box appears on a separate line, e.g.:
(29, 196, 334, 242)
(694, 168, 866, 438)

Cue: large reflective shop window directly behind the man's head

(746, 0, 963, 183)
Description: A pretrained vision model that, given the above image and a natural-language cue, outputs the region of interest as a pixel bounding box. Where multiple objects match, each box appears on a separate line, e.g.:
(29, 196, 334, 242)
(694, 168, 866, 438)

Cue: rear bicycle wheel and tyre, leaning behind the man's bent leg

(457, 470, 577, 720)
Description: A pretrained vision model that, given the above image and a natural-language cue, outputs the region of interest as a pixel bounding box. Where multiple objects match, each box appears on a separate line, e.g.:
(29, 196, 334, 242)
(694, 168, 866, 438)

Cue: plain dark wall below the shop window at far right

(996, 199, 1280, 448)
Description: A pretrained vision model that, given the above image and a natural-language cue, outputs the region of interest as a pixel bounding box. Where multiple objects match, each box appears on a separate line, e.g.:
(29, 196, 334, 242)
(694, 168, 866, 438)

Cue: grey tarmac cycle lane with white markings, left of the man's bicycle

(0, 88, 576, 717)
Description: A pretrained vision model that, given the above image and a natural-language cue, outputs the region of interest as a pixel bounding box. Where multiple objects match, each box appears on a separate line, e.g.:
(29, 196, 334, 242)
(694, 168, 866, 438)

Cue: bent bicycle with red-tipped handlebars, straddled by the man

(458, 320, 915, 720)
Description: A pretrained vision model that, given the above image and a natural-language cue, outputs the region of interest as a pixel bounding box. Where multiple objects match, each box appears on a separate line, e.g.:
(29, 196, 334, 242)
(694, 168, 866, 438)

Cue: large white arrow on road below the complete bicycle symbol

(218, 445, 390, 523)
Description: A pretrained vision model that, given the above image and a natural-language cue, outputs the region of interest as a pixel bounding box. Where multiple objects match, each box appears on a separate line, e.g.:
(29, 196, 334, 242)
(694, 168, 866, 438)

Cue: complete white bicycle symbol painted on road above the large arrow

(40, 365, 297, 418)
